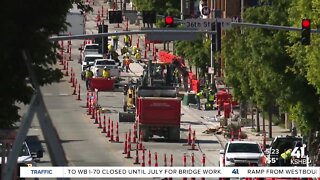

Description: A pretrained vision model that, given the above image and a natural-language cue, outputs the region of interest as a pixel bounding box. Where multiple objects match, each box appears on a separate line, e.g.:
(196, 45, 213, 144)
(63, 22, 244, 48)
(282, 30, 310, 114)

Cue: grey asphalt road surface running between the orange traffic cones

(20, 3, 225, 179)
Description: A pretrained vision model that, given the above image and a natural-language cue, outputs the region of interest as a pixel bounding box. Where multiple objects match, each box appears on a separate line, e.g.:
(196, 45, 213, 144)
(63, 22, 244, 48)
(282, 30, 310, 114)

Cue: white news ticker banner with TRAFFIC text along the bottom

(20, 166, 320, 178)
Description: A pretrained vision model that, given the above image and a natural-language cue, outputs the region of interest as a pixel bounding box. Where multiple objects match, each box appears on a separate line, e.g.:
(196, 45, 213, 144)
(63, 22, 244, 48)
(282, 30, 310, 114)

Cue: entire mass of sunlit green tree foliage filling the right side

(222, 0, 320, 133)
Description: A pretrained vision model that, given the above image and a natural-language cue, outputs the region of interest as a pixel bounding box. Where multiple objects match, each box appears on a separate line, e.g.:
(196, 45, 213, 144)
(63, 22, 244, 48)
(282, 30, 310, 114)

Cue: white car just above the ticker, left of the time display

(219, 141, 266, 167)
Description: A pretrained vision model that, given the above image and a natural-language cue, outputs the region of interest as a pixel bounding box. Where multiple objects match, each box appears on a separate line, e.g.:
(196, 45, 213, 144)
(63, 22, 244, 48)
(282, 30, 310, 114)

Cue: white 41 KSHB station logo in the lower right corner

(291, 144, 311, 165)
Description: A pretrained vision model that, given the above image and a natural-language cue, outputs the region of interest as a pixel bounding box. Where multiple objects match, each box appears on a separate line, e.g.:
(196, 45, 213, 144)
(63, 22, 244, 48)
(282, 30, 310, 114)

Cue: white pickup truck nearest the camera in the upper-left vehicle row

(92, 59, 120, 77)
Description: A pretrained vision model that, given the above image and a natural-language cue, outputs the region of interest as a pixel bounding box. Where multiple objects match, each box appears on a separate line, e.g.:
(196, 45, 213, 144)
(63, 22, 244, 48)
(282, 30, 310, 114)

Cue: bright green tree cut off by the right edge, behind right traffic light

(287, 0, 320, 137)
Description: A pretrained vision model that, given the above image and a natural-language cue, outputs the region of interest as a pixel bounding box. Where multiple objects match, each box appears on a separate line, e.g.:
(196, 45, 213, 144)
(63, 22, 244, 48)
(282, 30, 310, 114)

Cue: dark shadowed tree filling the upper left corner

(0, 0, 91, 128)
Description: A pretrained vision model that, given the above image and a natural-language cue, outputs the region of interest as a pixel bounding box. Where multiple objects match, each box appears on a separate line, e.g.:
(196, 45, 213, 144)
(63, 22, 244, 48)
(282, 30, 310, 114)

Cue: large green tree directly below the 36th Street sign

(223, 0, 318, 136)
